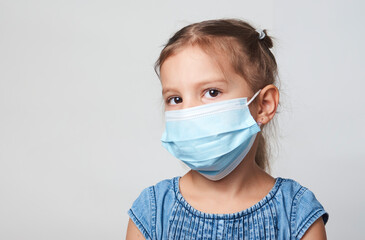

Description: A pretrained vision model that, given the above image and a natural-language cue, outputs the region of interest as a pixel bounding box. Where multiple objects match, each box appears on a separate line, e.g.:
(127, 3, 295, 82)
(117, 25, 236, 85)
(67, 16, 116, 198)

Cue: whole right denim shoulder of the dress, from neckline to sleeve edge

(275, 178, 328, 239)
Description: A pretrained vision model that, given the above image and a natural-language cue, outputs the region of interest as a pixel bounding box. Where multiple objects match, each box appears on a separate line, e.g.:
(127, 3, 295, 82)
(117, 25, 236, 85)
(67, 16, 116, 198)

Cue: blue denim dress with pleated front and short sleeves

(128, 177, 328, 240)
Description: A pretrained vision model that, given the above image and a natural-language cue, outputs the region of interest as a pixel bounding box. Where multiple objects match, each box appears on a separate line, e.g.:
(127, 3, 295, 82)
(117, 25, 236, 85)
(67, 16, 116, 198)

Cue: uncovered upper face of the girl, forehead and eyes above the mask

(160, 46, 254, 111)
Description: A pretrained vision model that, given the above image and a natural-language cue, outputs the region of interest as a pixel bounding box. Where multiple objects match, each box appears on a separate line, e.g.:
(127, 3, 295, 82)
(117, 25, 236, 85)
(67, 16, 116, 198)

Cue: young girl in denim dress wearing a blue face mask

(127, 19, 328, 240)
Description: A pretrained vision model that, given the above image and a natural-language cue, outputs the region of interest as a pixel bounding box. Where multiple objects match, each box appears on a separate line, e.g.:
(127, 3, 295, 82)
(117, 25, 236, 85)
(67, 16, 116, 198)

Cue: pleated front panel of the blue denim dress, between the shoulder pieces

(167, 178, 282, 240)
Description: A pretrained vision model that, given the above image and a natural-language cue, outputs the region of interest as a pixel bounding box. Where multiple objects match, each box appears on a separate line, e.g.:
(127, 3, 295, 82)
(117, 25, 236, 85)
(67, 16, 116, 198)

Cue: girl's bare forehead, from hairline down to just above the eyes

(160, 47, 249, 96)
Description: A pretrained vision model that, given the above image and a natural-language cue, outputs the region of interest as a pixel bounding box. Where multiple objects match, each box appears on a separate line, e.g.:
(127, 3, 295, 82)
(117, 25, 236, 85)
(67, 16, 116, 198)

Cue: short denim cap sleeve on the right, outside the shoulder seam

(290, 187, 328, 239)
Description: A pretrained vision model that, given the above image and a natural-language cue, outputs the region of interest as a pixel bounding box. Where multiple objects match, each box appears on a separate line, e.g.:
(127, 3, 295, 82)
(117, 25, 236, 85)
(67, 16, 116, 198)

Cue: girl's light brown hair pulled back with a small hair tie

(155, 19, 277, 170)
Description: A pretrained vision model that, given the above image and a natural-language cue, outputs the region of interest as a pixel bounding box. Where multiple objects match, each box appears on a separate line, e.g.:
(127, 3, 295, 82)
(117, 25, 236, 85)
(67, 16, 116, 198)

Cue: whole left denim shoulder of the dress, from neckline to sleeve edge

(128, 177, 178, 239)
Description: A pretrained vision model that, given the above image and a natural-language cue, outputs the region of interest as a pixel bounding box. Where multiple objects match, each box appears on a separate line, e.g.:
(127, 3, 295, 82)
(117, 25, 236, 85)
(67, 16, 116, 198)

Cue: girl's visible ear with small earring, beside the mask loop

(257, 84, 279, 124)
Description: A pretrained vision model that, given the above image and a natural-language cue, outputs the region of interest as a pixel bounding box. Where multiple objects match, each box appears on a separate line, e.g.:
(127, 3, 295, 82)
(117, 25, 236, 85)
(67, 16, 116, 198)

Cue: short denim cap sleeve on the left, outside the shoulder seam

(128, 186, 156, 240)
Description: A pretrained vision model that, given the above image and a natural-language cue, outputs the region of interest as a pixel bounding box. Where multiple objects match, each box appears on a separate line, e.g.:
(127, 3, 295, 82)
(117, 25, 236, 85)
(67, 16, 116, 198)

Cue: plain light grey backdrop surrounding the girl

(0, 0, 365, 240)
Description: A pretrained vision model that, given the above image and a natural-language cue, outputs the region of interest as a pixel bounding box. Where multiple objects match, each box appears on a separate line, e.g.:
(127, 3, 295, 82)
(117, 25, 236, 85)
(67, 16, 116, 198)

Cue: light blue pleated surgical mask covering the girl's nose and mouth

(161, 90, 261, 180)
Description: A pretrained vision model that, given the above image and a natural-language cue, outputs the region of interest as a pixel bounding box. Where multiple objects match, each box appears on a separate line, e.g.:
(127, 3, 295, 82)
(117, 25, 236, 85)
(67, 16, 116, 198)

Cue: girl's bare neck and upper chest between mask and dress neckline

(180, 139, 275, 213)
